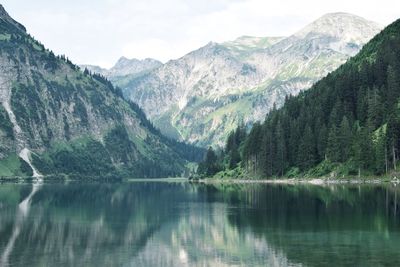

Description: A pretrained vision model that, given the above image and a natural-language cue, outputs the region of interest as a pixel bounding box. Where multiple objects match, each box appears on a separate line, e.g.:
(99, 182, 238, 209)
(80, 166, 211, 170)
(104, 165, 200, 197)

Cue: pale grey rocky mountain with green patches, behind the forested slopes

(121, 13, 381, 146)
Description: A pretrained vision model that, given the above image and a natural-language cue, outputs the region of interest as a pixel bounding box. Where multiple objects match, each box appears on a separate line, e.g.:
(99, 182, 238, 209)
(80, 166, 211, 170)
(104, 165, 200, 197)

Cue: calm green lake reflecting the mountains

(0, 181, 400, 267)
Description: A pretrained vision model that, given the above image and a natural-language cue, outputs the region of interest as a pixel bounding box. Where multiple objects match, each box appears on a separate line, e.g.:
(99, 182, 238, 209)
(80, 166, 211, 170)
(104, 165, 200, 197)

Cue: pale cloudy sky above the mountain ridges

(2, 0, 400, 68)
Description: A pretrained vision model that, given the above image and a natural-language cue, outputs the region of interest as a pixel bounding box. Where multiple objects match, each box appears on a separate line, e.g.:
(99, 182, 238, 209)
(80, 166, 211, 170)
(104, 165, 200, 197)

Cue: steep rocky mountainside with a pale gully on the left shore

(0, 6, 201, 177)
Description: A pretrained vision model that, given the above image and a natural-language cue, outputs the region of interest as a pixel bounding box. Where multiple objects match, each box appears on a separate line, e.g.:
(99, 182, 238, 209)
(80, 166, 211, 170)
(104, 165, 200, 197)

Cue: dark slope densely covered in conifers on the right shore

(205, 16, 400, 180)
